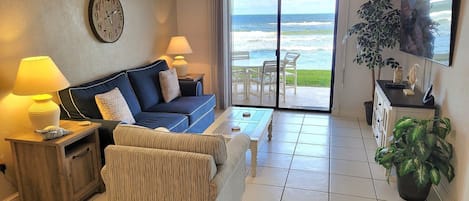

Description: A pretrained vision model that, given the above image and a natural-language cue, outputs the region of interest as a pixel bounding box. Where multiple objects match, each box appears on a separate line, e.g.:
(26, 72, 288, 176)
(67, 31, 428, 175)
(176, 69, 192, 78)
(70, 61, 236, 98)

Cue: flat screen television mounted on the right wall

(400, 0, 459, 66)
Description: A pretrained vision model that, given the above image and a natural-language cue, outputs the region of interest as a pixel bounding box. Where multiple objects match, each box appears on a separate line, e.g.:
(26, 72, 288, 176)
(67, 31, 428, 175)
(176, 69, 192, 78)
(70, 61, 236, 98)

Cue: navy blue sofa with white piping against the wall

(59, 60, 216, 159)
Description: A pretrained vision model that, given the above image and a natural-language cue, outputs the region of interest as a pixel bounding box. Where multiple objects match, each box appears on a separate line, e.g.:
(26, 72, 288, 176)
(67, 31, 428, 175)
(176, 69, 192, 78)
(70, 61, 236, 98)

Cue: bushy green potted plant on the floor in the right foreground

(375, 117, 454, 201)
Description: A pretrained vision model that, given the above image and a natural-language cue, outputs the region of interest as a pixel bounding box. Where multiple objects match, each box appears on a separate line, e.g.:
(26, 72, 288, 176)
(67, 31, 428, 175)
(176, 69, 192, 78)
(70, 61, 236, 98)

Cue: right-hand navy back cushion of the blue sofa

(126, 60, 169, 111)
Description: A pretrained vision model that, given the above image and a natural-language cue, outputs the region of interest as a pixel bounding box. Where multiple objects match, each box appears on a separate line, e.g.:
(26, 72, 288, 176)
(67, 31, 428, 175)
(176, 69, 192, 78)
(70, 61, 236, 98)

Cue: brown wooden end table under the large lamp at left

(6, 121, 102, 201)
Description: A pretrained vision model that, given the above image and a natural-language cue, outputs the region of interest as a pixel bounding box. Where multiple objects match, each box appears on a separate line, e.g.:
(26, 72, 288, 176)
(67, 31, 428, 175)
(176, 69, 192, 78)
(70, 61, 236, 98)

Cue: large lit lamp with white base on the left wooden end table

(13, 56, 70, 129)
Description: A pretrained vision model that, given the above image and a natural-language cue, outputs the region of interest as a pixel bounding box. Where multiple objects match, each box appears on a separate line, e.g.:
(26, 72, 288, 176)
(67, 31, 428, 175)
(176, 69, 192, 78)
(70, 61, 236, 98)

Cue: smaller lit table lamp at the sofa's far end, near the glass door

(166, 36, 192, 77)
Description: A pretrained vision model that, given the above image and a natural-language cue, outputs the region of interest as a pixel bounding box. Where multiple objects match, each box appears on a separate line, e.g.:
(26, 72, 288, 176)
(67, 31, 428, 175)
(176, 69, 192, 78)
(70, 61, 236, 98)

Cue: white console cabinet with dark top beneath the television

(372, 80, 435, 146)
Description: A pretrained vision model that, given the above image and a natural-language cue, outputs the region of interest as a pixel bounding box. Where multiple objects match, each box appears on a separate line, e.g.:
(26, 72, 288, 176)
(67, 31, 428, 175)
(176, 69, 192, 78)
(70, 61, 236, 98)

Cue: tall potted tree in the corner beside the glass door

(346, 0, 401, 125)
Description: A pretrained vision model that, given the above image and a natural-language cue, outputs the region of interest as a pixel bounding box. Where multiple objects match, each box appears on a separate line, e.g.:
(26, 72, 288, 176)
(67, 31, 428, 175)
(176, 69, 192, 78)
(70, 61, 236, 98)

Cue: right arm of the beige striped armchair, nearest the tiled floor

(211, 134, 251, 196)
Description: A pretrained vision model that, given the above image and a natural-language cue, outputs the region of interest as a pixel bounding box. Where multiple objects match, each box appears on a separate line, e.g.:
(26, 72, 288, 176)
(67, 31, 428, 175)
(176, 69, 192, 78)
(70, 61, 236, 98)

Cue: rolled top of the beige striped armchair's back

(114, 125, 227, 165)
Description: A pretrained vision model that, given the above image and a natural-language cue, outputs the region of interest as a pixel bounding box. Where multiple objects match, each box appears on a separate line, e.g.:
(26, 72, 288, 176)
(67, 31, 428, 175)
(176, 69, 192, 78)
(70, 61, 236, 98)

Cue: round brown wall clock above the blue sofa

(89, 0, 124, 43)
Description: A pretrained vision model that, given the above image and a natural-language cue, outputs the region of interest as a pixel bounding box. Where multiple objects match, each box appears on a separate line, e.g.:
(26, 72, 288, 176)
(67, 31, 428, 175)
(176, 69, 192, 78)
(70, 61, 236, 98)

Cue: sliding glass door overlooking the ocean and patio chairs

(231, 0, 336, 111)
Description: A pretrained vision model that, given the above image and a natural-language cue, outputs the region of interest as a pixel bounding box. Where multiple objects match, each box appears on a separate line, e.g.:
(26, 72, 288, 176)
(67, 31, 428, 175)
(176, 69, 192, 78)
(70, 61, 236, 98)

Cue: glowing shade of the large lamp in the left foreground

(13, 56, 70, 96)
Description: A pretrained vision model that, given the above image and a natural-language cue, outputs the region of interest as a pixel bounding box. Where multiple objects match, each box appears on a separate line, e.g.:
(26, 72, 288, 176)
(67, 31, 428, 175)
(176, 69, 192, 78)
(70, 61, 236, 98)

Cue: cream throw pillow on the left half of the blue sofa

(94, 87, 135, 124)
